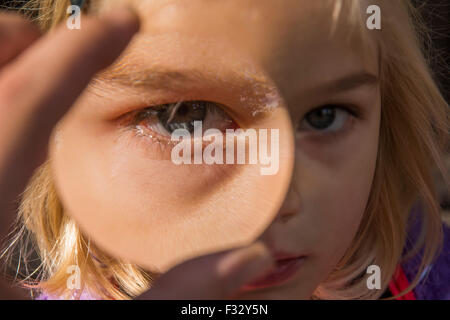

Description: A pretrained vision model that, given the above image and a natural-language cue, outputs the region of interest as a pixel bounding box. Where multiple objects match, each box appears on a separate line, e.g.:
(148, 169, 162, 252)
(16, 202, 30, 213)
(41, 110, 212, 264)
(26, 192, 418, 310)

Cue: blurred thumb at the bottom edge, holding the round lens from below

(138, 243, 274, 300)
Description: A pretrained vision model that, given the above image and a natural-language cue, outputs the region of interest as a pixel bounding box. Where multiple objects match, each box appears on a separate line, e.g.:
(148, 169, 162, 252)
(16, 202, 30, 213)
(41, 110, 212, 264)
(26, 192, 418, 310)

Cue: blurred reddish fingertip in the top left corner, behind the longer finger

(0, 13, 41, 67)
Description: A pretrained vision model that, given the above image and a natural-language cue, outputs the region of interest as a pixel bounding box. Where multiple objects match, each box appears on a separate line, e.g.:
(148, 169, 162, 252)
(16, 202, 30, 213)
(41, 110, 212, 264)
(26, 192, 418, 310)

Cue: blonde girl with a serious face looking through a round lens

(0, 0, 450, 299)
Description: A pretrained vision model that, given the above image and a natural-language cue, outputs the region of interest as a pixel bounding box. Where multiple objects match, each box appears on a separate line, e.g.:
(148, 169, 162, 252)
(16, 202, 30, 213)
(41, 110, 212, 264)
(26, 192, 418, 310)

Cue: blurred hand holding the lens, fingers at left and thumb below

(0, 9, 273, 299)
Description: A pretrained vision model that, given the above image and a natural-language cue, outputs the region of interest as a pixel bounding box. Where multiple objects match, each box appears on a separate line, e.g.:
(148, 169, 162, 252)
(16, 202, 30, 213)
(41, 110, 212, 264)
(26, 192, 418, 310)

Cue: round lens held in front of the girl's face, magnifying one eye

(51, 1, 294, 272)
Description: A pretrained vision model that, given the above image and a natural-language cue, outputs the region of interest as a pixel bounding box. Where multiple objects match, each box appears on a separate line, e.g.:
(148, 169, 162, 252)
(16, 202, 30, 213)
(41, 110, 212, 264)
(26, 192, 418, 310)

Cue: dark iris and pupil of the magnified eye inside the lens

(158, 101, 207, 133)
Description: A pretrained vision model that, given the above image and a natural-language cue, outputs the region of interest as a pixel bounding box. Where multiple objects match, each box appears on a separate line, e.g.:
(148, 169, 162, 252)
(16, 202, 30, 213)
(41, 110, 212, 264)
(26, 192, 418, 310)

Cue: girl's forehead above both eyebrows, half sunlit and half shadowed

(94, 0, 377, 103)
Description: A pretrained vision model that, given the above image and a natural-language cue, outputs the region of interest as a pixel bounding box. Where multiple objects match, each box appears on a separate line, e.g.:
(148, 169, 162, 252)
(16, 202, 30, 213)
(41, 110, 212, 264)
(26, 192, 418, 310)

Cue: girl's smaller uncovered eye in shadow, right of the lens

(300, 105, 352, 132)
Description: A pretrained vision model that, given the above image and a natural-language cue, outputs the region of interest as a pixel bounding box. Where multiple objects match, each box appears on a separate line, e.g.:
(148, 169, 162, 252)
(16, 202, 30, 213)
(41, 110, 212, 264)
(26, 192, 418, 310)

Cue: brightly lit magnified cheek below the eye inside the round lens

(51, 106, 293, 272)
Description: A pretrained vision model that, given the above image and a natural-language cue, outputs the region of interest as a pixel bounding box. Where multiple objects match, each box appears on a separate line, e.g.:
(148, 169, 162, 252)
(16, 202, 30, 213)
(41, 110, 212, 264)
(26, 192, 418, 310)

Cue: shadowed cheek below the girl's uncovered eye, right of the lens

(297, 110, 379, 273)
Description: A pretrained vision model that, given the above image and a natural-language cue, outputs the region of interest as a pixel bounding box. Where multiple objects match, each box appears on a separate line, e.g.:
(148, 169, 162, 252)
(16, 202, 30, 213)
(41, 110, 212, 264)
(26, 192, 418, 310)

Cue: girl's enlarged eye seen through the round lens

(134, 101, 237, 137)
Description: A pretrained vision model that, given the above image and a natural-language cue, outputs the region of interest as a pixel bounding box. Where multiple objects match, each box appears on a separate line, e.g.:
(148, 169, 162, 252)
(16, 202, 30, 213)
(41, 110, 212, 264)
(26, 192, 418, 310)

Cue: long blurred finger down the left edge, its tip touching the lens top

(0, 9, 139, 264)
